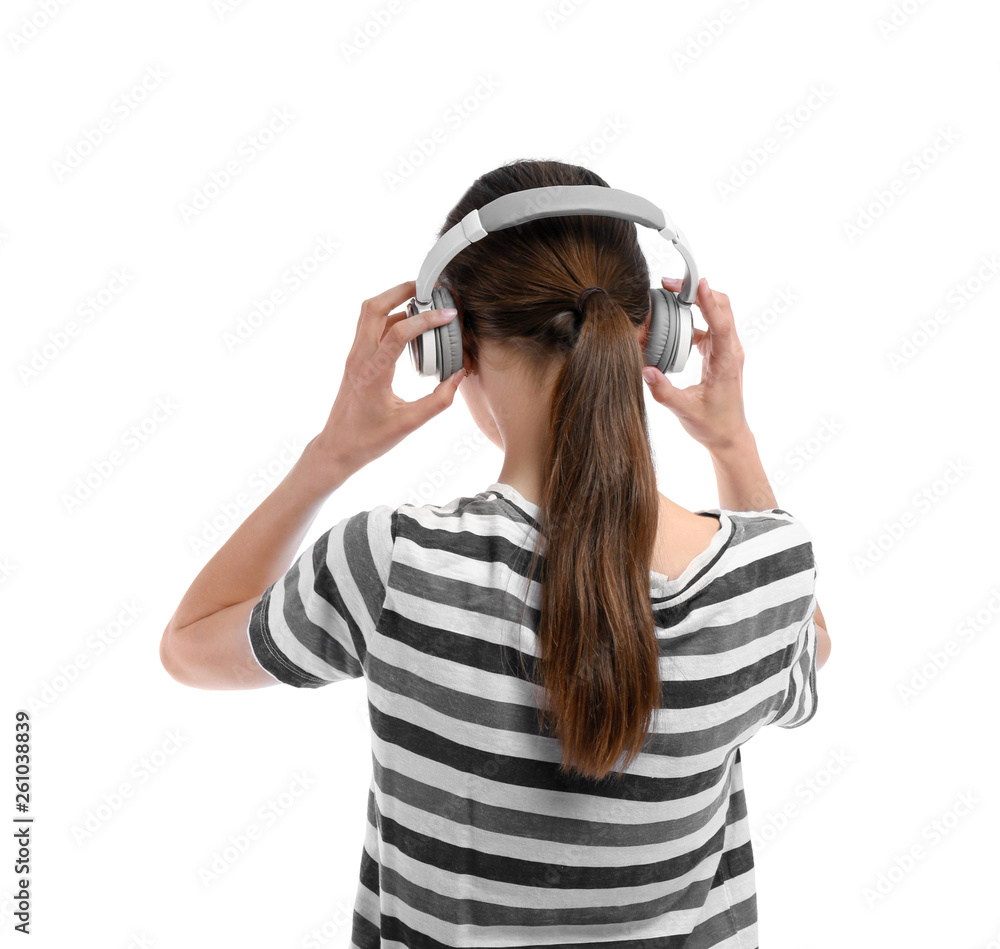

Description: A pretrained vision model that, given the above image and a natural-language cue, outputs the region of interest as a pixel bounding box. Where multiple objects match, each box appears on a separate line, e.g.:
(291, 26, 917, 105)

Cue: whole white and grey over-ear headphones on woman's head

(406, 185, 698, 381)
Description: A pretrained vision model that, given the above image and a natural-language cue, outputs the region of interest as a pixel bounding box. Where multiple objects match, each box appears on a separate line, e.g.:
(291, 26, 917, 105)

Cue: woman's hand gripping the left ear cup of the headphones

(308, 280, 464, 476)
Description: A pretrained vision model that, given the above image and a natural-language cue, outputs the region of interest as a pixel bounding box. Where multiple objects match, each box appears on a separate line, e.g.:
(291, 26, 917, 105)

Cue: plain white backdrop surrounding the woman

(0, 0, 1000, 949)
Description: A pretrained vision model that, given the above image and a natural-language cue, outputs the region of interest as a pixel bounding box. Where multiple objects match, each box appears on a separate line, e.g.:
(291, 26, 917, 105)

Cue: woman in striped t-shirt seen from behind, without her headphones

(161, 161, 829, 949)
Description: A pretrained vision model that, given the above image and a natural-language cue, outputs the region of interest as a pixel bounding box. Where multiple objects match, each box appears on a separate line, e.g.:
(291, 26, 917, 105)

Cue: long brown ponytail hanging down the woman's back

(528, 293, 661, 780)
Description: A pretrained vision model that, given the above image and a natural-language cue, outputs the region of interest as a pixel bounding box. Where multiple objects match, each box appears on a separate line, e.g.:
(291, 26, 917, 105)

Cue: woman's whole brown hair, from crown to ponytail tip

(439, 160, 661, 780)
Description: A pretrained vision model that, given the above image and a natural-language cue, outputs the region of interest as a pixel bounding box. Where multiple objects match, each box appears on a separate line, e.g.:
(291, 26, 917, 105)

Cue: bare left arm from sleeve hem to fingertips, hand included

(160, 280, 463, 689)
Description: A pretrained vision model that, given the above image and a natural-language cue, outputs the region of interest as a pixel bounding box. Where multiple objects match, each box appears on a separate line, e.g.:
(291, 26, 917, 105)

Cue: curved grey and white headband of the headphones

(416, 185, 698, 307)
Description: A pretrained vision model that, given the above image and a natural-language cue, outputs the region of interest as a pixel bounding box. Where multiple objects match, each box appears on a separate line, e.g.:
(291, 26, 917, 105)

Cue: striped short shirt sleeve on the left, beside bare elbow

(247, 505, 395, 689)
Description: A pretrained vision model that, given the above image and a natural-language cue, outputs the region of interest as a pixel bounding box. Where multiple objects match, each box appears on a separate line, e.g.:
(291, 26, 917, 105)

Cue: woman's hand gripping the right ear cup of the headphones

(643, 277, 750, 452)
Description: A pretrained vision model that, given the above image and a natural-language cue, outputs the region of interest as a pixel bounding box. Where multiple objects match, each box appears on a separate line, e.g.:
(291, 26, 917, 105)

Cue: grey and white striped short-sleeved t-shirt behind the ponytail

(248, 482, 816, 949)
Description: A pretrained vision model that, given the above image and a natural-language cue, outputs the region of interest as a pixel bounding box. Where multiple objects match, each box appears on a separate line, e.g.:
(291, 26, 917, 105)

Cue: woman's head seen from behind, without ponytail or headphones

(438, 160, 649, 448)
